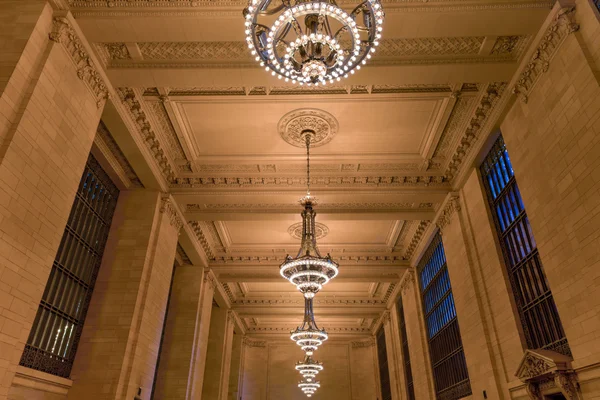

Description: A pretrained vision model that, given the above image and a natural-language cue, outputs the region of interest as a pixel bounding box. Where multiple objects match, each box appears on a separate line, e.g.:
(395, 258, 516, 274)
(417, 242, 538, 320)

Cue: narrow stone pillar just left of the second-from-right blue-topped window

(400, 269, 435, 399)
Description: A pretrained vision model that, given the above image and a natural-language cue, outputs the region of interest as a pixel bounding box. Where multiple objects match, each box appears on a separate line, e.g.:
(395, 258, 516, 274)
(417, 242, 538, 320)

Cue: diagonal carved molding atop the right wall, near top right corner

(512, 7, 579, 103)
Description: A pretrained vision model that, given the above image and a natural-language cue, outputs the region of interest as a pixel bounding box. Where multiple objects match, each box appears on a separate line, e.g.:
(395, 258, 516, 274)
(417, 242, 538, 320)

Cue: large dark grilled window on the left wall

(21, 155, 119, 377)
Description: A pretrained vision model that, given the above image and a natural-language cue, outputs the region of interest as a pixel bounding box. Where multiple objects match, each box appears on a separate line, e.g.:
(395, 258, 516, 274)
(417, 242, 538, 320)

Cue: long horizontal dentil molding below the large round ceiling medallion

(171, 175, 448, 189)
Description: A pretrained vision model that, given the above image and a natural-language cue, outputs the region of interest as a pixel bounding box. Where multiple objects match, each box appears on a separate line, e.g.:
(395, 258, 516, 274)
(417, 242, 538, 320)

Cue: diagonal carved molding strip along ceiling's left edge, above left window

(117, 88, 175, 183)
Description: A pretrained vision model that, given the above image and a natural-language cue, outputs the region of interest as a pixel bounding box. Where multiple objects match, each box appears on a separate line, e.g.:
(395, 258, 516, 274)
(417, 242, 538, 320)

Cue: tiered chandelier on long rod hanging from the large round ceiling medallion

(279, 130, 339, 298)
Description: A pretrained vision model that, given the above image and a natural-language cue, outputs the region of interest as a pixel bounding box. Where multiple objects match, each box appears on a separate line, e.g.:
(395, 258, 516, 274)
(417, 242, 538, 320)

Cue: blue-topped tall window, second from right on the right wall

(417, 234, 471, 400)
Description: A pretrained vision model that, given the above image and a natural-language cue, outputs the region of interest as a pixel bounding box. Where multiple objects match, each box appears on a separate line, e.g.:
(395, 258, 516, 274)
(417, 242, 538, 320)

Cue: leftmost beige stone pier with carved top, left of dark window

(0, 4, 107, 399)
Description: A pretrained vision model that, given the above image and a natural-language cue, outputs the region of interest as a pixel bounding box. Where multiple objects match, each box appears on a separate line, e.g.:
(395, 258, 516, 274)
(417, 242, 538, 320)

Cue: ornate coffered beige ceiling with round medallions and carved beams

(77, 0, 553, 336)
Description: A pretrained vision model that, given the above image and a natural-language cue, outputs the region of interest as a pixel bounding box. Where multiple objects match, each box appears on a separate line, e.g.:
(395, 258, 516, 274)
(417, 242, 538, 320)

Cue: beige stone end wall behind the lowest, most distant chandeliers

(240, 341, 377, 400)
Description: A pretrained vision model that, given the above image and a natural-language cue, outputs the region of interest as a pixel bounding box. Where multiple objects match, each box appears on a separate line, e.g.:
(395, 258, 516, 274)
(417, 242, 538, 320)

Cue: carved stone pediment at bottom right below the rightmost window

(515, 349, 582, 400)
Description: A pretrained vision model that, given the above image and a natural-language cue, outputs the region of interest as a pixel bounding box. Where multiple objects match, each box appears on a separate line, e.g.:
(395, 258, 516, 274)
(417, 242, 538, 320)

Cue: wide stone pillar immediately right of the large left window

(69, 190, 183, 400)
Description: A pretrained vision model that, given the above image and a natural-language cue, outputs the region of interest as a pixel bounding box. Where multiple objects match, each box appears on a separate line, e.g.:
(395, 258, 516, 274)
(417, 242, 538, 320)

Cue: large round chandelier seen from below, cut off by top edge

(244, 0, 384, 85)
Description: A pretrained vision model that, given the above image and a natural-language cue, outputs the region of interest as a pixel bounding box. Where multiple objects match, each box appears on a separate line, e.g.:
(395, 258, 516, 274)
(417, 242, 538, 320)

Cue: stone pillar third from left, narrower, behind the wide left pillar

(154, 264, 215, 400)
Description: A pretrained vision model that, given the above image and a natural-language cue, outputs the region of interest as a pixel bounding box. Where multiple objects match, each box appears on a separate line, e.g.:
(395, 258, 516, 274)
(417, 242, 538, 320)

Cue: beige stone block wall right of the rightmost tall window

(501, 0, 600, 398)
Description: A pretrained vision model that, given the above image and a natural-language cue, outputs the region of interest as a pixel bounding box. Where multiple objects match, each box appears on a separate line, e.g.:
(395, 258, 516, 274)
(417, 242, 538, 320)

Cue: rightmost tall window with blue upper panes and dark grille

(481, 136, 571, 355)
